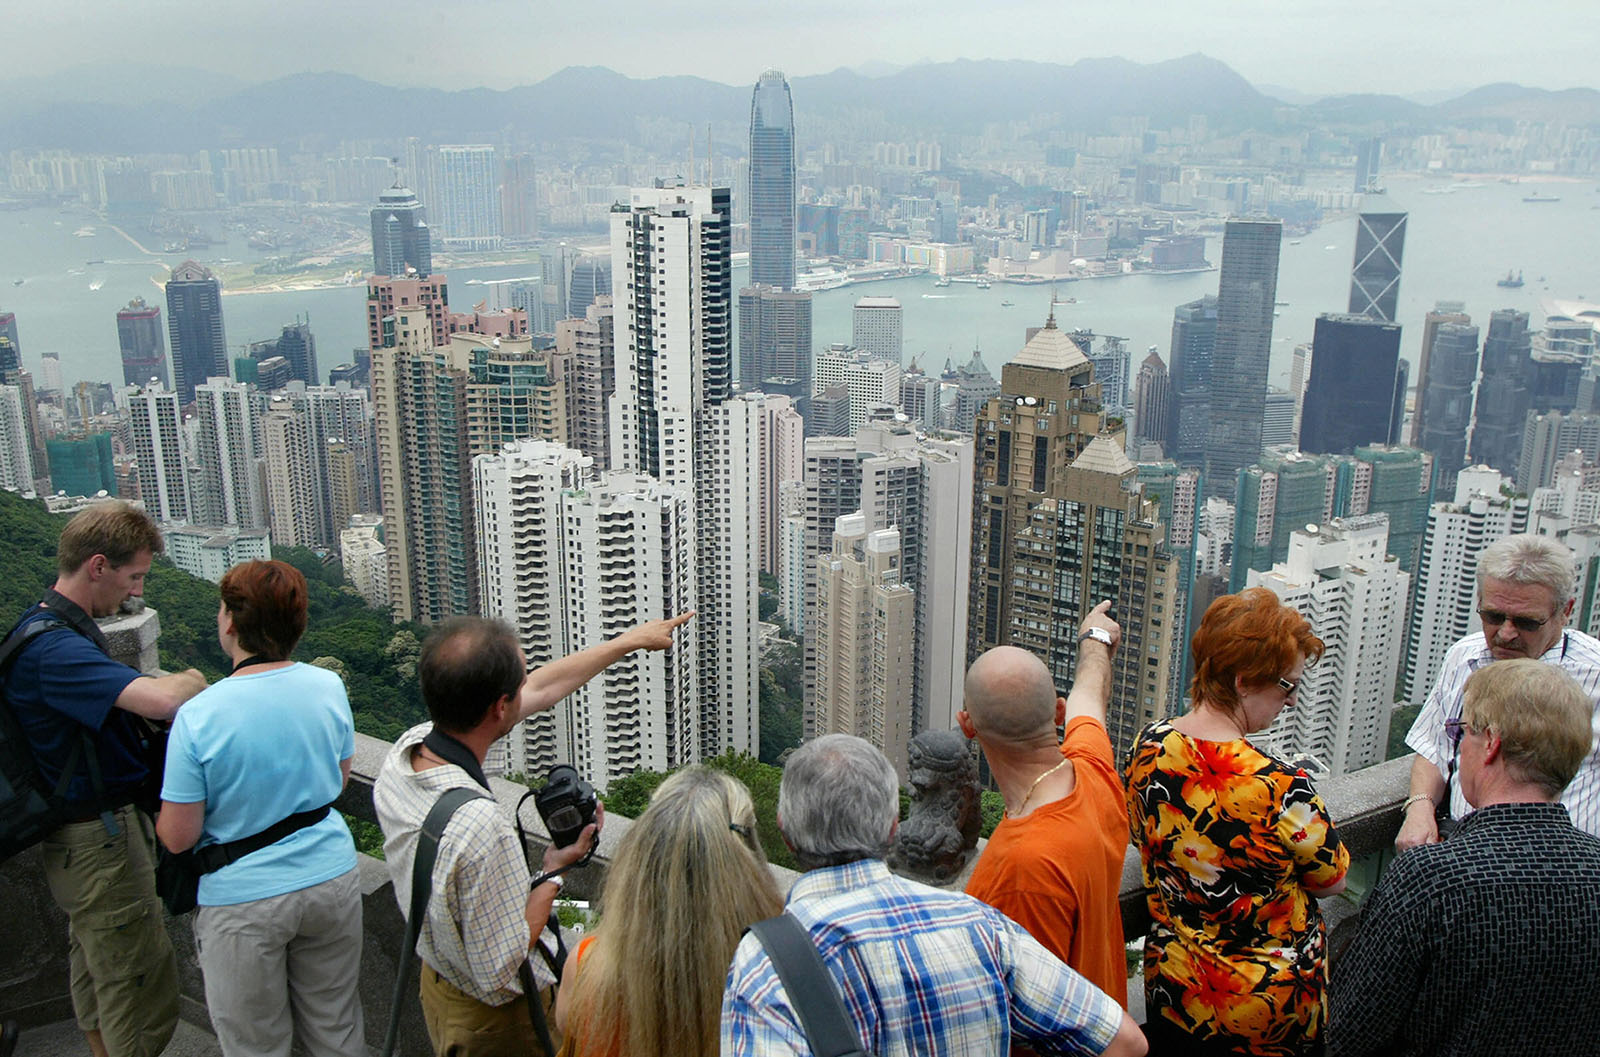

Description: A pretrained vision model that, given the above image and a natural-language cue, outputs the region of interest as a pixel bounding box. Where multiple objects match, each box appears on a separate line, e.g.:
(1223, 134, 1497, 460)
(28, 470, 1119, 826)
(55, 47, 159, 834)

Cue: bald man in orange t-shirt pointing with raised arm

(955, 601, 1128, 1007)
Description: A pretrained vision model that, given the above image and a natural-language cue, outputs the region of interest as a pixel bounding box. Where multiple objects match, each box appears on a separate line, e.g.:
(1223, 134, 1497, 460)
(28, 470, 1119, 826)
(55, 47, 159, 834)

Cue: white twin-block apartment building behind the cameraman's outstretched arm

(474, 441, 701, 787)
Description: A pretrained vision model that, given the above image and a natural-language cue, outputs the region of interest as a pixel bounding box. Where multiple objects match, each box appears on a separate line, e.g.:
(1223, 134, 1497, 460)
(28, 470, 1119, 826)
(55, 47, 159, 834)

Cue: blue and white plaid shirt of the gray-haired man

(722, 859, 1123, 1057)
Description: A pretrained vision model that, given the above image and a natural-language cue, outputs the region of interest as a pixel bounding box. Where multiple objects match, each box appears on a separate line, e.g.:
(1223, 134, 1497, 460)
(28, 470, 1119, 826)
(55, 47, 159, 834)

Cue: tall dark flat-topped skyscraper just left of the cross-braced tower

(1205, 221, 1283, 497)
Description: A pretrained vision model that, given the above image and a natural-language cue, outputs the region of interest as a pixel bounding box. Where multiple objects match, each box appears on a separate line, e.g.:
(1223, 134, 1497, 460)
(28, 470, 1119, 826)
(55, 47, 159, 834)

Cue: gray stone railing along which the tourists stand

(0, 609, 1410, 1057)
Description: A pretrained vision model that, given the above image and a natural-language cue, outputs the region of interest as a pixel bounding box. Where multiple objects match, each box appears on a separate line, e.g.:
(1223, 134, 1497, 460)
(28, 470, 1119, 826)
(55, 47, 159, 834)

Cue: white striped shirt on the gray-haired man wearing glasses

(1405, 628, 1600, 836)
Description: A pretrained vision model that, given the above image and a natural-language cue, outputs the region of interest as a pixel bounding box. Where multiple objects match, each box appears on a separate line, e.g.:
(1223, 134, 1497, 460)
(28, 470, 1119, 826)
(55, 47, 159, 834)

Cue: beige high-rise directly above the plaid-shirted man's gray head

(813, 512, 917, 770)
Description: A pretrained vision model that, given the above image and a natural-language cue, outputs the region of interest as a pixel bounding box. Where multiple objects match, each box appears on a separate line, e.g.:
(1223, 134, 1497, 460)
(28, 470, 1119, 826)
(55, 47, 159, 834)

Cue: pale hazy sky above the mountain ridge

(12, 0, 1600, 93)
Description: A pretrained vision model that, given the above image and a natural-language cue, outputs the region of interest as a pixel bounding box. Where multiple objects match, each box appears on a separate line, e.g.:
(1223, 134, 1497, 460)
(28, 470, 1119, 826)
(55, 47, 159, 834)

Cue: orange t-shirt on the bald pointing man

(966, 716, 1128, 1009)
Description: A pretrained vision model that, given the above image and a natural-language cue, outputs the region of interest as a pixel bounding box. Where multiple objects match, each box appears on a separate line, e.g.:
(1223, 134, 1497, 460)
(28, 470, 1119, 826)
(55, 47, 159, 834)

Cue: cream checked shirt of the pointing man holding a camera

(373, 723, 555, 1006)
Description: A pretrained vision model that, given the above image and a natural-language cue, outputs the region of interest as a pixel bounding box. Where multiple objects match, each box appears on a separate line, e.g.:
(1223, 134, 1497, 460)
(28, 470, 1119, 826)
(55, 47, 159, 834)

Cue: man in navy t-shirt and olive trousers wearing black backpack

(5, 502, 205, 1057)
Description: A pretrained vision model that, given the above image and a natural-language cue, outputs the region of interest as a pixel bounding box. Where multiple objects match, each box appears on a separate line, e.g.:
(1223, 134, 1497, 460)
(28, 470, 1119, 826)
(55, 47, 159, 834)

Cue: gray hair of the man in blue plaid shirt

(778, 734, 899, 870)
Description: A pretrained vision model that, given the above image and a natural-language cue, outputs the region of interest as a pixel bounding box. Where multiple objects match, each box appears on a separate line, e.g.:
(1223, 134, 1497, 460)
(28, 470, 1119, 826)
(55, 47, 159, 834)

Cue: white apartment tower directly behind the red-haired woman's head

(1250, 513, 1411, 776)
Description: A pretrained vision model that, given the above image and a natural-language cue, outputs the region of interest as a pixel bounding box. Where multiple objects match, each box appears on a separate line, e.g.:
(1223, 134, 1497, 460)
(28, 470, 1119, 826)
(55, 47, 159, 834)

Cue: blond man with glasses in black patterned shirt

(1328, 660, 1600, 1057)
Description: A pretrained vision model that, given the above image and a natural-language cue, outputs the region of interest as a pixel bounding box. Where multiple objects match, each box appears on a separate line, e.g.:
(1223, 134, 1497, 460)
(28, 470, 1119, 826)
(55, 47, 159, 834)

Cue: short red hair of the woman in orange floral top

(1189, 587, 1322, 712)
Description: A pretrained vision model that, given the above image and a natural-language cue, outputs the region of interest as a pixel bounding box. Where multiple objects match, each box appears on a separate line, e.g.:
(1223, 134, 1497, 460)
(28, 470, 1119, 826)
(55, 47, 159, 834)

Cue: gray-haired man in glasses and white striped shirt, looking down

(1395, 534, 1600, 851)
